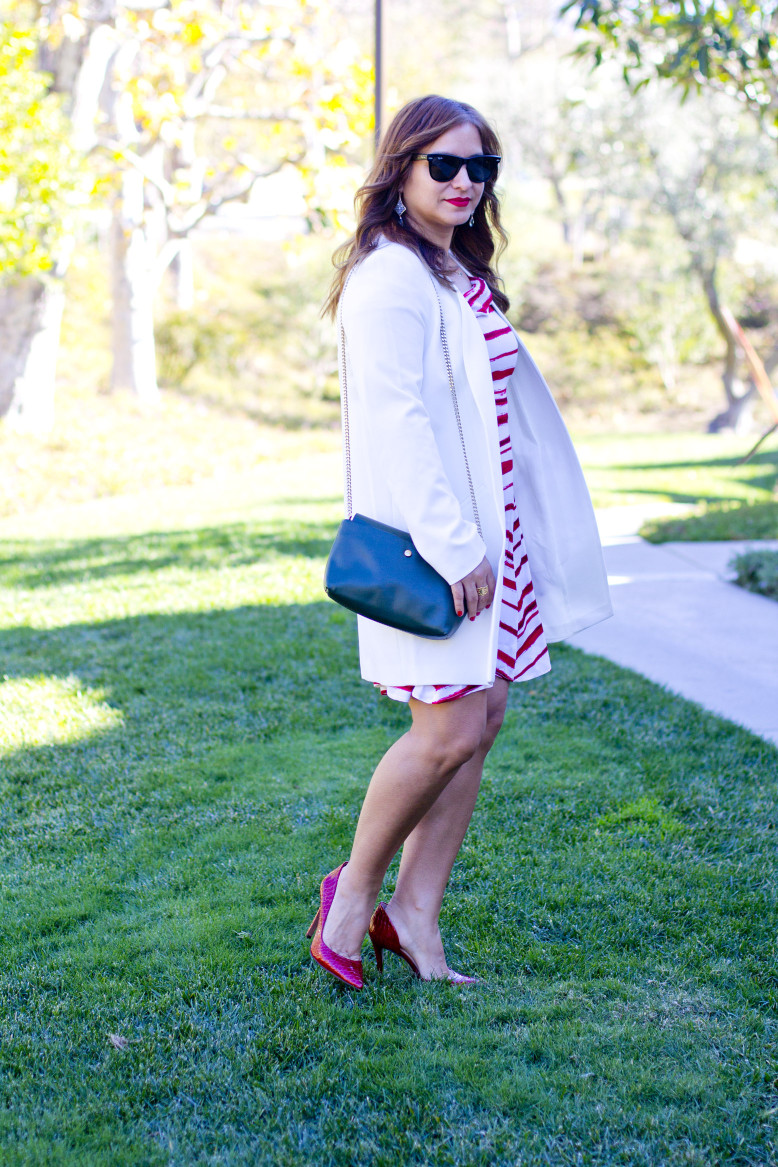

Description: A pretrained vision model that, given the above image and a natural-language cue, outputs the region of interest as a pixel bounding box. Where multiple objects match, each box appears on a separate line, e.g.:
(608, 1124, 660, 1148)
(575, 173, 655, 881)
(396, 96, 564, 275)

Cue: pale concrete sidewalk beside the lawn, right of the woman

(570, 508, 778, 745)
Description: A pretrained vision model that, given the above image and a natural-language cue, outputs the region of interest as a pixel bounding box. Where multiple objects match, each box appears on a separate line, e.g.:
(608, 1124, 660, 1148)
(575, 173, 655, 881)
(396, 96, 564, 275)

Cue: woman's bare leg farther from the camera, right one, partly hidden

(388, 679, 509, 979)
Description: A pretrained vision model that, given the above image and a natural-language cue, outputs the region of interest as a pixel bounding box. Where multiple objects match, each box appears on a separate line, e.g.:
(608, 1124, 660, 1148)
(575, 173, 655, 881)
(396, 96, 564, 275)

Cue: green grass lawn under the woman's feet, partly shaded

(0, 450, 778, 1167)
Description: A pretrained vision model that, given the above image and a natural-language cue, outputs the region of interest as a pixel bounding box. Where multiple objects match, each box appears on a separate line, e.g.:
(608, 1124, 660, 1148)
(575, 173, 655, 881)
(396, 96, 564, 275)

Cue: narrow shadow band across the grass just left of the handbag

(0, 515, 337, 588)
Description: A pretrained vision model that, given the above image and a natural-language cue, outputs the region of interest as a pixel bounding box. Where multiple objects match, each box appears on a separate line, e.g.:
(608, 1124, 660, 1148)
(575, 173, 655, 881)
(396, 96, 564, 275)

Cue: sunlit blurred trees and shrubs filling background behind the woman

(0, 0, 778, 505)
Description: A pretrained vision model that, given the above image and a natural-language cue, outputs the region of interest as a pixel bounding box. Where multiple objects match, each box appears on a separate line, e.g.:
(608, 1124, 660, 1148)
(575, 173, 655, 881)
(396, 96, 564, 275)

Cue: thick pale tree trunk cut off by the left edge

(0, 275, 64, 433)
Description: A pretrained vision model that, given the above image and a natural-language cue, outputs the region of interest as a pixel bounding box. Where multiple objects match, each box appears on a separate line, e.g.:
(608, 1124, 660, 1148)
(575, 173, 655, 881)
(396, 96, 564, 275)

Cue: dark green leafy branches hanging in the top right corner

(562, 0, 778, 135)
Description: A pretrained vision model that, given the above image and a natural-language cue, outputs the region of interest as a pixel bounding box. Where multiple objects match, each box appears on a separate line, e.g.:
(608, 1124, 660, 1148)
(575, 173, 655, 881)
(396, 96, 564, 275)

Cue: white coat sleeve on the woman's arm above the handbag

(341, 245, 486, 584)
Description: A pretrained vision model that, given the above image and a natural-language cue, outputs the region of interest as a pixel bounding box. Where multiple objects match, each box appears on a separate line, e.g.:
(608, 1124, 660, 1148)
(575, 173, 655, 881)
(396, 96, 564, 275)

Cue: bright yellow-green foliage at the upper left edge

(0, 23, 78, 280)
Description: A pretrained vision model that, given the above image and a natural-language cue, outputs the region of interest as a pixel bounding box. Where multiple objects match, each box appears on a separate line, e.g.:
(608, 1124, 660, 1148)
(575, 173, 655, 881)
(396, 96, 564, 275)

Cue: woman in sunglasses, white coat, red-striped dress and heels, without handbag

(308, 97, 610, 988)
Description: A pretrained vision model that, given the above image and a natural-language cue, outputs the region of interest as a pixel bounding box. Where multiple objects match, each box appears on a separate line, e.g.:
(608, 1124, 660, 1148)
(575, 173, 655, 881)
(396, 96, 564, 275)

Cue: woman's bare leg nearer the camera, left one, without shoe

(323, 691, 486, 959)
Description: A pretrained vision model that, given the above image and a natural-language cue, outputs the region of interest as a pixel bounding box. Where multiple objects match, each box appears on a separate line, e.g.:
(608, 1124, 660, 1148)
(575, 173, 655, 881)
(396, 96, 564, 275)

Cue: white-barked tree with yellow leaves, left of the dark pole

(80, 0, 370, 401)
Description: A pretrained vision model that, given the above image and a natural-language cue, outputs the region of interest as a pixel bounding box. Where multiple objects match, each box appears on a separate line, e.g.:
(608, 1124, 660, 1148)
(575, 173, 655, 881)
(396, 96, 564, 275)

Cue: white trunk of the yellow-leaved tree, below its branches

(111, 170, 159, 405)
